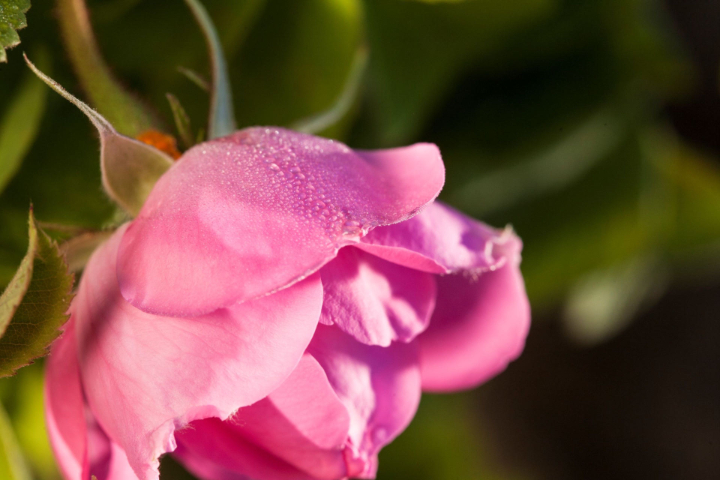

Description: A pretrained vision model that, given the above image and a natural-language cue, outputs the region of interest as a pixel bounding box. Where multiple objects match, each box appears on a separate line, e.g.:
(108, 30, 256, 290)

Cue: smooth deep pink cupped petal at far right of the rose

(418, 261, 530, 392)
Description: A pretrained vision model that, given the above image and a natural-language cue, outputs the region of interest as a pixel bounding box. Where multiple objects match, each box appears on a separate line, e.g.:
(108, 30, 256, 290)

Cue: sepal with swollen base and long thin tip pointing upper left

(25, 57, 173, 216)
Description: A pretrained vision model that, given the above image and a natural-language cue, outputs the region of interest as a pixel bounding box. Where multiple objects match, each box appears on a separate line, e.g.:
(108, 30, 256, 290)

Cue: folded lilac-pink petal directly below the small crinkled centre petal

(308, 325, 421, 478)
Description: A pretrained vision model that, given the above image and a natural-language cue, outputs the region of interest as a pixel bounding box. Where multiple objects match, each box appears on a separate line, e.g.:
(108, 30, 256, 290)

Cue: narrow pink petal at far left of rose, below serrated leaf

(45, 320, 87, 480)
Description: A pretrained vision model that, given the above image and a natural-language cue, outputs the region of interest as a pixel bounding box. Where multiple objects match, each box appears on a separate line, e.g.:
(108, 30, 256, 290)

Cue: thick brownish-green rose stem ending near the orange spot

(57, 0, 157, 137)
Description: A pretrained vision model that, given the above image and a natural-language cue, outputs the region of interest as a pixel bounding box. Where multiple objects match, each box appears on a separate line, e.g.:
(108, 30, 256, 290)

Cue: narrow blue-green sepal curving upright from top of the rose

(185, 0, 236, 139)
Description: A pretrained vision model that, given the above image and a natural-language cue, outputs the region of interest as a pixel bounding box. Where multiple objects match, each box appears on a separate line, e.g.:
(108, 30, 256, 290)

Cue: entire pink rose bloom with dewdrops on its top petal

(46, 128, 529, 480)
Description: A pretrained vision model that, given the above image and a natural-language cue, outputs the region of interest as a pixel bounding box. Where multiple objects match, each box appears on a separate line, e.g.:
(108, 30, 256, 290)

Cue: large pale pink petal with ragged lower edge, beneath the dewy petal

(74, 227, 322, 480)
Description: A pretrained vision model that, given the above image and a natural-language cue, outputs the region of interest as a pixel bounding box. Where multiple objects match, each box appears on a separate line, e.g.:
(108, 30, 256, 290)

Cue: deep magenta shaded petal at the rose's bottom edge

(173, 418, 316, 480)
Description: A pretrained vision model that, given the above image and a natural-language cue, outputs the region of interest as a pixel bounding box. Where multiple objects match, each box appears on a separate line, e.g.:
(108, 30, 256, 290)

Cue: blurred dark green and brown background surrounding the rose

(0, 0, 720, 480)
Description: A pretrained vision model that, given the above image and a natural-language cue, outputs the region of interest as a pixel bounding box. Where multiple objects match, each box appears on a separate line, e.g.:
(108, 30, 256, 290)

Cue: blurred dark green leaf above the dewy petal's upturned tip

(366, 0, 559, 145)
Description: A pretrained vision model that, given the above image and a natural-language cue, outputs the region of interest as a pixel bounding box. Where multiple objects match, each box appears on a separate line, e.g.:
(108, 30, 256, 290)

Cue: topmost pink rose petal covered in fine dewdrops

(118, 128, 445, 316)
